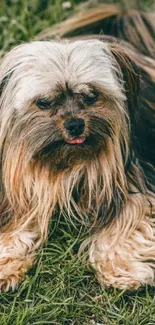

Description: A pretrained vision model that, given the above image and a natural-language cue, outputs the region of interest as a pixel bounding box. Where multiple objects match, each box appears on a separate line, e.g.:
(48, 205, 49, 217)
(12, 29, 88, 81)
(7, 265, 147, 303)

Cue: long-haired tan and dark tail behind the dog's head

(37, 4, 155, 58)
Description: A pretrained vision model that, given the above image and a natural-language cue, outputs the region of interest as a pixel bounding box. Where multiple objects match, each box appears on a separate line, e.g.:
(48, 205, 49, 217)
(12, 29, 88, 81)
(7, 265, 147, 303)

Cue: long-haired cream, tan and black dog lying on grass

(0, 6, 155, 291)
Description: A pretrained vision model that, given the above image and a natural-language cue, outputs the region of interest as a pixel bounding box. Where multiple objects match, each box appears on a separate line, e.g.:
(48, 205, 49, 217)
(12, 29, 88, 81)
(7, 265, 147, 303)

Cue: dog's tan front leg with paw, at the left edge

(0, 225, 39, 291)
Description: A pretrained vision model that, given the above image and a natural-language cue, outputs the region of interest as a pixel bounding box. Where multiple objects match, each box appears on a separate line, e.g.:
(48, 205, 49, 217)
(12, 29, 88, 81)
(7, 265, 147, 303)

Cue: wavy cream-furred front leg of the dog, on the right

(89, 194, 155, 290)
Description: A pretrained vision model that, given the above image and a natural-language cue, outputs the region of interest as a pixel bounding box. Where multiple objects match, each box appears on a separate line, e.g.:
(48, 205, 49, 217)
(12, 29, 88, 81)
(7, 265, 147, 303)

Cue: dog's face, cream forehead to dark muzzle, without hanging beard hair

(1, 40, 126, 170)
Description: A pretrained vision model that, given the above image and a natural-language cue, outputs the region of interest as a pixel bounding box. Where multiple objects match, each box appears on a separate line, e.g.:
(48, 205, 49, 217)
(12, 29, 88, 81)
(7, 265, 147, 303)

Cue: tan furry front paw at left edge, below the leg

(0, 255, 34, 292)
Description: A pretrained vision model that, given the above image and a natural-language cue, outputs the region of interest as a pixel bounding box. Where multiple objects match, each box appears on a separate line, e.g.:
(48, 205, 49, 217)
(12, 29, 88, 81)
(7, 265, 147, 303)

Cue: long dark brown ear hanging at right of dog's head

(109, 43, 143, 162)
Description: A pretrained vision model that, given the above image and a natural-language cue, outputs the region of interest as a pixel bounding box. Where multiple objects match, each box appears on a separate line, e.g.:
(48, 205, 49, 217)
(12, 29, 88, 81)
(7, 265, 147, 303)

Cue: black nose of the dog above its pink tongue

(64, 118, 85, 136)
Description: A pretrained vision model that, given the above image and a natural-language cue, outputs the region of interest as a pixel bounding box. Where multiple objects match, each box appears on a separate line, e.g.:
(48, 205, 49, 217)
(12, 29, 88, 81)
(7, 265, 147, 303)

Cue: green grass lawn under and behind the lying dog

(0, 0, 155, 325)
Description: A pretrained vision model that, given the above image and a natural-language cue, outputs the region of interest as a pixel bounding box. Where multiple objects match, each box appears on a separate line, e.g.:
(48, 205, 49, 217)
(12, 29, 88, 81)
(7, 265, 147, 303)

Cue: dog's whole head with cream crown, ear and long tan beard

(0, 40, 140, 227)
